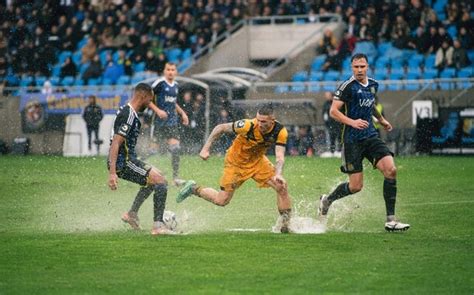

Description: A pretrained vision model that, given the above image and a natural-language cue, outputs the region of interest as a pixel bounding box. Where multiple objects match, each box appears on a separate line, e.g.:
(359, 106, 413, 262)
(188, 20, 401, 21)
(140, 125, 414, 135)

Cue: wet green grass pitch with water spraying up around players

(0, 156, 474, 294)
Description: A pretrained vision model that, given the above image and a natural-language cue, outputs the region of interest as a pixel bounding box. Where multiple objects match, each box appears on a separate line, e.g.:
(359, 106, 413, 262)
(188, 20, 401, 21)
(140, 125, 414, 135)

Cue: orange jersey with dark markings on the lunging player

(226, 119, 288, 168)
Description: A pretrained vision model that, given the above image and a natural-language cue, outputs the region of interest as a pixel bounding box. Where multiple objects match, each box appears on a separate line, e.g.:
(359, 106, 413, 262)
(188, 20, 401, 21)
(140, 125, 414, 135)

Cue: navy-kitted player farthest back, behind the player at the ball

(150, 62, 189, 185)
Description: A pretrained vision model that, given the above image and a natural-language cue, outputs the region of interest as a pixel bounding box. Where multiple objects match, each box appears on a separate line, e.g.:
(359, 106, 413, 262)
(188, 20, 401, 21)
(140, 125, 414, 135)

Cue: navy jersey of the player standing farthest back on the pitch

(151, 78, 179, 126)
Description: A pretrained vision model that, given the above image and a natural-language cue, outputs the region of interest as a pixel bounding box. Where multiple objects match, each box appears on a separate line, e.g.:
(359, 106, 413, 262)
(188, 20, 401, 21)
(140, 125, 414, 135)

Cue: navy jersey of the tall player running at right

(334, 76, 379, 142)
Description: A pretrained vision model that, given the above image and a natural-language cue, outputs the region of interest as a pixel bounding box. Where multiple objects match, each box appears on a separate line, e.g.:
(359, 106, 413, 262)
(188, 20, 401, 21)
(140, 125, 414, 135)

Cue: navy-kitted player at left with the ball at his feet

(107, 83, 171, 235)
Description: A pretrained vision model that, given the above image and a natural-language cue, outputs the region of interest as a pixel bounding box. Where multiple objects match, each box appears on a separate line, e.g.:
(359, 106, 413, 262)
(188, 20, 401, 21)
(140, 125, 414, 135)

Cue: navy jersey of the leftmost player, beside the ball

(110, 104, 142, 169)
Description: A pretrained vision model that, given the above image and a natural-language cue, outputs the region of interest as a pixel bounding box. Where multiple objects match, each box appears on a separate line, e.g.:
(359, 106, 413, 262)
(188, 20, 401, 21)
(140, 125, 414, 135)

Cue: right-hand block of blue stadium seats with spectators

(288, 0, 474, 92)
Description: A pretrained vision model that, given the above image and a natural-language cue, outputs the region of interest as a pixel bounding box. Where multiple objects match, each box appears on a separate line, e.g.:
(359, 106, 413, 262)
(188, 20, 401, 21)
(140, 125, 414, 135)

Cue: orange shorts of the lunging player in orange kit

(220, 156, 275, 192)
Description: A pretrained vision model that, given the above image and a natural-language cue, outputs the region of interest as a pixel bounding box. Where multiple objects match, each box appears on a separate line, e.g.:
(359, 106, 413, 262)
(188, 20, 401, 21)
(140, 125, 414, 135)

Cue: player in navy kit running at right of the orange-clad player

(318, 54, 410, 231)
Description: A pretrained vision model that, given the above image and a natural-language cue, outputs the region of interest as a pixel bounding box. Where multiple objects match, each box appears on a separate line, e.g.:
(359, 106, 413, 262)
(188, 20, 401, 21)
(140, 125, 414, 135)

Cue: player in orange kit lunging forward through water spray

(176, 105, 291, 233)
